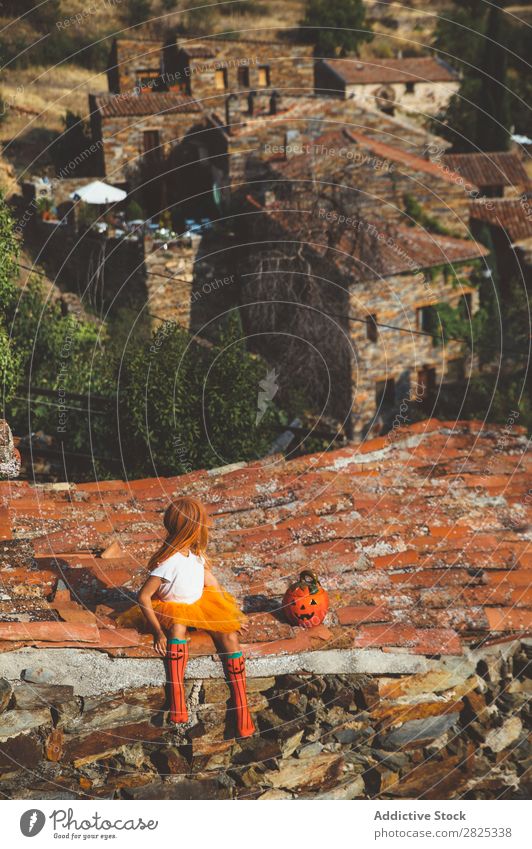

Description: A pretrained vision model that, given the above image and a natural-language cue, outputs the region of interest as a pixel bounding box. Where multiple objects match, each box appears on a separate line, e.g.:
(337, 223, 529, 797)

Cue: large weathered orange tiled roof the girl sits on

(0, 420, 532, 657)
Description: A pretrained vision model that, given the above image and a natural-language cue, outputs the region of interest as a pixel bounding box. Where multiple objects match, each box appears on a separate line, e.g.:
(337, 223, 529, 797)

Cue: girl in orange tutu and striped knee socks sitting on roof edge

(118, 497, 255, 737)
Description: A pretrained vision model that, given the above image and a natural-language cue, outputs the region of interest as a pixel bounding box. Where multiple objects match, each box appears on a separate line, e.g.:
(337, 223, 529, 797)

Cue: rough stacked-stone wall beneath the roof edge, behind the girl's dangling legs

(0, 641, 532, 799)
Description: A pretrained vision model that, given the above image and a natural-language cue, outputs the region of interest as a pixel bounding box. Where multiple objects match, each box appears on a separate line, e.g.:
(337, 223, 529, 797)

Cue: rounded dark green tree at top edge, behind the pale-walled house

(301, 0, 373, 56)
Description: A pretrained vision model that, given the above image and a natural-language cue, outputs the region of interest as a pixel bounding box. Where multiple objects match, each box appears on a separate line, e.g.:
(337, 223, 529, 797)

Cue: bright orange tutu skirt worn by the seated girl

(116, 587, 247, 634)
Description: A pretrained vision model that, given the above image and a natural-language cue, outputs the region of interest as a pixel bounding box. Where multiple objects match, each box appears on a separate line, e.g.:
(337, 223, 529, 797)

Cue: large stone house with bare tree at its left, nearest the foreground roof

(241, 197, 488, 439)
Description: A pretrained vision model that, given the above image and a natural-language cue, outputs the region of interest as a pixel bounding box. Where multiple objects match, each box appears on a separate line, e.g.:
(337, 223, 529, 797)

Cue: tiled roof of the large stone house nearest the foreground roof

(264, 203, 489, 276)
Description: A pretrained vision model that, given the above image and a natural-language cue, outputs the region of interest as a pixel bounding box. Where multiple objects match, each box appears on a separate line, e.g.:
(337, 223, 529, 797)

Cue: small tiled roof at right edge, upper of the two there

(442, 151, 530, 187)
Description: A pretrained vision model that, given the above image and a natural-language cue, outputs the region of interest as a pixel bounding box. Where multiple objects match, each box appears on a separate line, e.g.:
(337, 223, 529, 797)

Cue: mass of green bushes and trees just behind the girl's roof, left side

(0, 195, 280, 477)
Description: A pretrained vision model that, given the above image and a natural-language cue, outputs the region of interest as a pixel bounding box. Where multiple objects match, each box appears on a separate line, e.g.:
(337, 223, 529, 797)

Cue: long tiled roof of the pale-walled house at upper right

(323, 56, 458, 85)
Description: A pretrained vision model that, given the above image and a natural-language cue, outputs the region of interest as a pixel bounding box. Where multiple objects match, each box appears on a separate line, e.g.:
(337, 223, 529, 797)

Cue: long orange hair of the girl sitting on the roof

(149, 496, 209, 569)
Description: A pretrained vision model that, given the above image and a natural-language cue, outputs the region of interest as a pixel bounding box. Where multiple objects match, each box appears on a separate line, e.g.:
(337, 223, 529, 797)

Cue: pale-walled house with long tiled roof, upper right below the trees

(316, 56, 460, 115)
